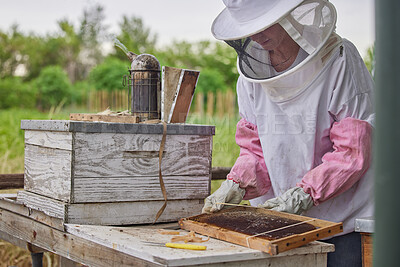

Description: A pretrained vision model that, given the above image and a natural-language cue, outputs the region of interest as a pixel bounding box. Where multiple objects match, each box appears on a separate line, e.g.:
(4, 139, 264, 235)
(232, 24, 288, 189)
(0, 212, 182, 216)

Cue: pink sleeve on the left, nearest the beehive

(227, 119, 271, 199)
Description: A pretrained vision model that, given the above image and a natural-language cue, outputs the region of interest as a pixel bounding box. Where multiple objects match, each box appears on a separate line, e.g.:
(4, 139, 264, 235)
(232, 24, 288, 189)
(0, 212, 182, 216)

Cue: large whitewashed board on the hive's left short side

(24, 144, 72, 201)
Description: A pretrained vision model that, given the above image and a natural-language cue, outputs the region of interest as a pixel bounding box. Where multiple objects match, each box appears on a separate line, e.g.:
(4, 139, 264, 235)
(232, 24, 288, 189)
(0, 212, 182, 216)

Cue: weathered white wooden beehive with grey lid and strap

(18, 120, 215, 224)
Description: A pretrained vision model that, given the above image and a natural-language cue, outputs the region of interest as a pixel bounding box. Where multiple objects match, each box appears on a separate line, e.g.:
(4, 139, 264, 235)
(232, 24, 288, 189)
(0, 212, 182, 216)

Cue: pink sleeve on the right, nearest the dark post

(297, 118, 372, 205)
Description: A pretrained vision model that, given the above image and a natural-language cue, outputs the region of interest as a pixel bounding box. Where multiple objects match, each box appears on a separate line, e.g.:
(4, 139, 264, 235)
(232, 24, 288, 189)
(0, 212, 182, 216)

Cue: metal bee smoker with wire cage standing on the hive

(128, 52, 161, 122)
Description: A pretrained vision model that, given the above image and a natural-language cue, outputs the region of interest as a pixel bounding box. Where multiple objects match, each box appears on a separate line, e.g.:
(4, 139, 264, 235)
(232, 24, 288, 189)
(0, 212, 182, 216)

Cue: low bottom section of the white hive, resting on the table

(17, 191, 204, 225)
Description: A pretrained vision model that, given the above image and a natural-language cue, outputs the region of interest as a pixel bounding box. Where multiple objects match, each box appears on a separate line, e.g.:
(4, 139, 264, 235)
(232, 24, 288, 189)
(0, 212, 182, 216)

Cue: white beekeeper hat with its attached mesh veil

(211, 0, 341, 101)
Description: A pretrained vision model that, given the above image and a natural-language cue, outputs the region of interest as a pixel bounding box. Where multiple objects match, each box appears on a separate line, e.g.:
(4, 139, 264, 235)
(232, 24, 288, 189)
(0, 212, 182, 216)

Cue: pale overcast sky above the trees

(0, 0, 375, 56)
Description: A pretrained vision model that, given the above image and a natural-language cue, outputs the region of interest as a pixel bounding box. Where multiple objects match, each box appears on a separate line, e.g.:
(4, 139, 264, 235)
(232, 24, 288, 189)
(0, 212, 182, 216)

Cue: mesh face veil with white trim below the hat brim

(225, 0, 341, 100)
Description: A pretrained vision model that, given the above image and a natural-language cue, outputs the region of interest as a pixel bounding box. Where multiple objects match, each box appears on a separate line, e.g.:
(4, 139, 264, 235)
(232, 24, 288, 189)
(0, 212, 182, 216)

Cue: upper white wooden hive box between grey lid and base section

(24, 127, 212, 203)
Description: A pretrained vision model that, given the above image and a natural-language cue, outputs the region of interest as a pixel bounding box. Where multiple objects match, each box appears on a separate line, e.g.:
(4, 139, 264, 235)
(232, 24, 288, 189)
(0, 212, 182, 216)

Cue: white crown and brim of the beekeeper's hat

(211, 0, 304, 40)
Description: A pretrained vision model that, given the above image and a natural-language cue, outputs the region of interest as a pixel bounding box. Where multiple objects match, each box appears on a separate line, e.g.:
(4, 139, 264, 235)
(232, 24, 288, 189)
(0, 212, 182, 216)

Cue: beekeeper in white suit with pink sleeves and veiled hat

(203, 0, 374, 266)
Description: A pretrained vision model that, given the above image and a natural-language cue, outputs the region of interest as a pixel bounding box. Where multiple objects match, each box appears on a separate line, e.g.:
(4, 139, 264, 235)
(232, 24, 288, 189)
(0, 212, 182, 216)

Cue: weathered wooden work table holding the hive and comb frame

(0, 195, 334, 266)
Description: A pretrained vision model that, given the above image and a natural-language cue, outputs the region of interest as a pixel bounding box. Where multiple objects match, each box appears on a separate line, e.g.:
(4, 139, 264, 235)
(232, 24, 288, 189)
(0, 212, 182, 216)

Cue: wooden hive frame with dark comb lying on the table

(179, 207, 343, 255)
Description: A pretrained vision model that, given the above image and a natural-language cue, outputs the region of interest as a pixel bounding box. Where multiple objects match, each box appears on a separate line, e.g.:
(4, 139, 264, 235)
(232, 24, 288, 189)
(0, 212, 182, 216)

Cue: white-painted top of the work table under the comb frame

(66, 224, 334, 267)
